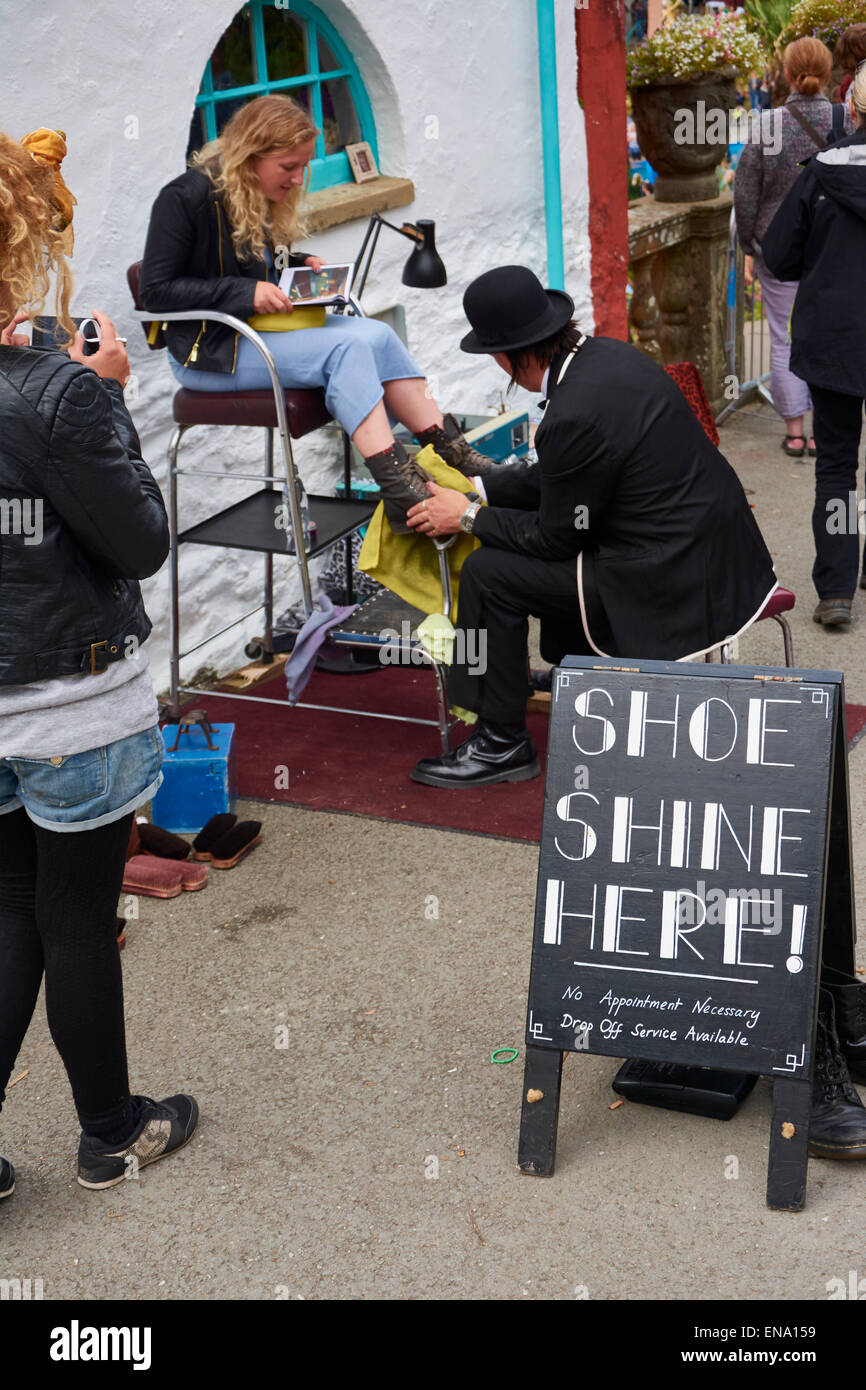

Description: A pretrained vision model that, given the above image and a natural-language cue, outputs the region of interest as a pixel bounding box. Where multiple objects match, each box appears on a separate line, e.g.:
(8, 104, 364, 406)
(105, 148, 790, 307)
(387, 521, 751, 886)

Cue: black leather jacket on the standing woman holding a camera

(0, 348, 168, 685)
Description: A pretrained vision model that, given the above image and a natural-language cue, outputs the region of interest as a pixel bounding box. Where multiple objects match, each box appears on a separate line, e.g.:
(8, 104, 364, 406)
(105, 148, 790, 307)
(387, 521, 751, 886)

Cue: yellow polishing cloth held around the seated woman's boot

(357, 443, 481, 621)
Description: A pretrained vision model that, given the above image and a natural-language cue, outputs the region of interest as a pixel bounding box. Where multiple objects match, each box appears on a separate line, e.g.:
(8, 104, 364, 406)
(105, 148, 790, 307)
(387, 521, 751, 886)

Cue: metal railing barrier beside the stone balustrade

(716, 211, 773, 424)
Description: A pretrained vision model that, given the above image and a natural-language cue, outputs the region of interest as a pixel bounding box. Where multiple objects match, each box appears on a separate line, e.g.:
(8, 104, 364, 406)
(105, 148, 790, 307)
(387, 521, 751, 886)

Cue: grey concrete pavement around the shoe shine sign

(0, 406, 866, 1301)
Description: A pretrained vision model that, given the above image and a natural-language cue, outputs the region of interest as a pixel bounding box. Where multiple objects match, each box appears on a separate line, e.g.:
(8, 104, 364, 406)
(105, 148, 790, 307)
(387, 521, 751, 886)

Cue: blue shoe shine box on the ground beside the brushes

(153, 724, 238, 835)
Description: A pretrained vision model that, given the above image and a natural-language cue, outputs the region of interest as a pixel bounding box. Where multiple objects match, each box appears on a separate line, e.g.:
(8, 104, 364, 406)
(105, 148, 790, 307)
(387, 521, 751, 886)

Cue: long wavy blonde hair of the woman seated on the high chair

(190, 93, 318, 260)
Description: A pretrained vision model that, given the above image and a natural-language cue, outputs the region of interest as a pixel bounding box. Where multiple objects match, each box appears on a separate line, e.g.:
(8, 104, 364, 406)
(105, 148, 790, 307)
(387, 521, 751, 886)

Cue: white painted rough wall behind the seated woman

(0, 0, 592, 688)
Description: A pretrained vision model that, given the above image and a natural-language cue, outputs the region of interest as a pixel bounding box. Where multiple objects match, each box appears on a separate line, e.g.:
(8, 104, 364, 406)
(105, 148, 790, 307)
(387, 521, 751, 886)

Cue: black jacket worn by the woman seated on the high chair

(139, 168, 312, 373)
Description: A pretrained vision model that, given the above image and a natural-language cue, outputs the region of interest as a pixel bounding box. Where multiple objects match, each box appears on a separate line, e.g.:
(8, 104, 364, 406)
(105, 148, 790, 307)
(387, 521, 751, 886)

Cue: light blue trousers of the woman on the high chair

(168, 314, 424, 435)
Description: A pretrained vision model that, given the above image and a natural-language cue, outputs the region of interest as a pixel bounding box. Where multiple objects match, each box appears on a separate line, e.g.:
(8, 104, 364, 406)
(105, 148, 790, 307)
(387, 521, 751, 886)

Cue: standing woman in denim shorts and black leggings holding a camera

(0, 131, 197, 1197)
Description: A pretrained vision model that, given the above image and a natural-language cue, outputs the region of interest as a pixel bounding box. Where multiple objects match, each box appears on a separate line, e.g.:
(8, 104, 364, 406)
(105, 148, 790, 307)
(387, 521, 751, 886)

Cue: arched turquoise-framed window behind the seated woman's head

(186, 0, 378, 189)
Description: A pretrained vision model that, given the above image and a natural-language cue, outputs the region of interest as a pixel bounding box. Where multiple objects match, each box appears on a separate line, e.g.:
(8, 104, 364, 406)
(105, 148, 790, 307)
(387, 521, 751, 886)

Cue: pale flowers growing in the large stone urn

(627, 13, 767, 88)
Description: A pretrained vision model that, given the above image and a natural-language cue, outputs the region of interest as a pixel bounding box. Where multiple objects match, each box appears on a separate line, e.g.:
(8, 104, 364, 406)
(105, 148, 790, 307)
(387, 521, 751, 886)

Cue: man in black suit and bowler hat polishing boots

(407, 265, 777, 787)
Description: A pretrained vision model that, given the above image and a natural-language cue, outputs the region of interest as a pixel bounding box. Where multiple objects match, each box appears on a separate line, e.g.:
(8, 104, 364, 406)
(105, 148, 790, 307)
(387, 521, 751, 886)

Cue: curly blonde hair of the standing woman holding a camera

(0, 132, 75, 346)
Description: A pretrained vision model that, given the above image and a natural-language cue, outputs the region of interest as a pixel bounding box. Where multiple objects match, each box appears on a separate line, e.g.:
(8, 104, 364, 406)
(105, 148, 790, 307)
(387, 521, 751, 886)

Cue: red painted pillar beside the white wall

(574, 0, 628, 342)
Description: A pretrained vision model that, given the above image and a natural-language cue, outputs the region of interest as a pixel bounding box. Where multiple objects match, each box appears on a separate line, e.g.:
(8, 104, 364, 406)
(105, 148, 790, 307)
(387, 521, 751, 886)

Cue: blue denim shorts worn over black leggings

(0, 724, 165, 831)
